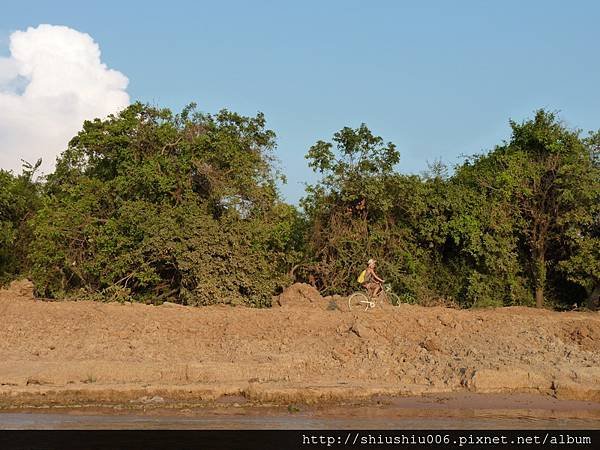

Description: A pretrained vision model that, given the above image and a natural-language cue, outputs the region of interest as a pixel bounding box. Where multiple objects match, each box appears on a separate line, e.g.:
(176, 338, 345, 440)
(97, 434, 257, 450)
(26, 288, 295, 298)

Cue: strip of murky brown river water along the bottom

(0, 393, 600, 430)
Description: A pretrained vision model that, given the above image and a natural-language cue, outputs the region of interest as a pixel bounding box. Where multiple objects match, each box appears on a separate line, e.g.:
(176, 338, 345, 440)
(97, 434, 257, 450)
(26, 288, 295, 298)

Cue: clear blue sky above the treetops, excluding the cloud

(0, 0, 600, 202)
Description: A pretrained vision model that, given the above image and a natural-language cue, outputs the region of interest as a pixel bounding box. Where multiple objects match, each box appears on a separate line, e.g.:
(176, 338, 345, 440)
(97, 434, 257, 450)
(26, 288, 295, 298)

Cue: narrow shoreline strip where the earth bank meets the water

(0, 383, 600, 419)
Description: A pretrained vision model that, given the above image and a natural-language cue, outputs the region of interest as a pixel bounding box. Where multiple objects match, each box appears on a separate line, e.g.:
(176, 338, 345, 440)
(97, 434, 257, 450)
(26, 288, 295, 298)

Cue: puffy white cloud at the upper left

(0, 25, 129, 173)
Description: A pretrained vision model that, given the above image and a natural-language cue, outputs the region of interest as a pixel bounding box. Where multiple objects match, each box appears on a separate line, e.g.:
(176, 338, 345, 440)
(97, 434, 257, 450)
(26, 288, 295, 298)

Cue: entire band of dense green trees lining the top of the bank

(0, 103, 600, 307)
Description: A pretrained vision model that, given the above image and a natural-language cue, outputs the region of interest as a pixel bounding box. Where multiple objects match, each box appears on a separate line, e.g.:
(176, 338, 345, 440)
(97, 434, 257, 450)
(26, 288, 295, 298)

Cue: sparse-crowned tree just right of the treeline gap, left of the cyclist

(301, 124, 410, 292)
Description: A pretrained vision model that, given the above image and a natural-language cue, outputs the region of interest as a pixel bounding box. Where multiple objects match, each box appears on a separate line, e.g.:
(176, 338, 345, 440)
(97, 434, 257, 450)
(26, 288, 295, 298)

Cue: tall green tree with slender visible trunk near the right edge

(458, 110, 600, 307)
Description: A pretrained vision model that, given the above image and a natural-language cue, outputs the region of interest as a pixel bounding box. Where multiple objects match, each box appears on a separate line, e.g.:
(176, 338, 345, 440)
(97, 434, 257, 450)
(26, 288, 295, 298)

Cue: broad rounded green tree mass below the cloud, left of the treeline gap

(30, 103, 297, 306)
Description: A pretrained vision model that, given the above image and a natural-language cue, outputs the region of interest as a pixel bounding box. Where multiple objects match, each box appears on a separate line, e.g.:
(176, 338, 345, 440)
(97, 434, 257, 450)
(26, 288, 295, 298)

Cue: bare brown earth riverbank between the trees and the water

(0, 282, 600, 408)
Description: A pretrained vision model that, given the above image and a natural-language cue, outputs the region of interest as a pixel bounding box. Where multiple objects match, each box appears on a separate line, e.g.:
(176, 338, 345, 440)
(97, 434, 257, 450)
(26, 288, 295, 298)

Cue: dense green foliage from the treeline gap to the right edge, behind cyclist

(303, 111, 600, 307)
